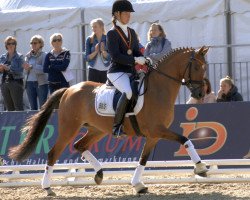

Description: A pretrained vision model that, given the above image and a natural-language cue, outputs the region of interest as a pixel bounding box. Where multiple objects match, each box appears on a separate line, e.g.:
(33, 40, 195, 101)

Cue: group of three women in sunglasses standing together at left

(0, 33, 70, 111)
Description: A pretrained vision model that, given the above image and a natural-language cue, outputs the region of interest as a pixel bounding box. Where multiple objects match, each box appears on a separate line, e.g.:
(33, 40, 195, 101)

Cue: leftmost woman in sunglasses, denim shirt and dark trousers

(0, 36, 24, 111)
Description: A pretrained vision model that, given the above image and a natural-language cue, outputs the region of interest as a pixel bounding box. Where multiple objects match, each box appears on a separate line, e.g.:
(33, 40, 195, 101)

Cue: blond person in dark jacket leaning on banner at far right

(216, 76, 243, 102)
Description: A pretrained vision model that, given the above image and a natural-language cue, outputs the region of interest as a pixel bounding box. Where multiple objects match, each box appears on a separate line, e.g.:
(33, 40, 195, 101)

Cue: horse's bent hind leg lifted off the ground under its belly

(74, 127, 105, 185)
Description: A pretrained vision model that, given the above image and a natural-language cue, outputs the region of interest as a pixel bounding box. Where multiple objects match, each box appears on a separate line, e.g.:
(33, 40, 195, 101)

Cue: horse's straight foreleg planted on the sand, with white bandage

(131, 138, 158, 193)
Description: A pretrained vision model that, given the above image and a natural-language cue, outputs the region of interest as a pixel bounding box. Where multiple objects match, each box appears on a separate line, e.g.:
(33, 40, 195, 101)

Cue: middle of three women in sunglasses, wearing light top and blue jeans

(24, 35, 48, 110)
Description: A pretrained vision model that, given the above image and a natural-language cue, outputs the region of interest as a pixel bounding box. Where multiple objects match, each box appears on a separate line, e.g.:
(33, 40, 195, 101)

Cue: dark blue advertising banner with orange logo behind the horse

(0, 102, 250, 165)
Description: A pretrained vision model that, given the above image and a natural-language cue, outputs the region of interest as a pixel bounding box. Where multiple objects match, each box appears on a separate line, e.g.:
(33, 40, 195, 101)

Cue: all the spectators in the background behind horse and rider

(0, 18, 243, 111)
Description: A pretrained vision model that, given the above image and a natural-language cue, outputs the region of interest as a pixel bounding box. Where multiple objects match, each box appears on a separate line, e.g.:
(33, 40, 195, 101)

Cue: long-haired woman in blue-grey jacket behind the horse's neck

(144, 23, 172, 63)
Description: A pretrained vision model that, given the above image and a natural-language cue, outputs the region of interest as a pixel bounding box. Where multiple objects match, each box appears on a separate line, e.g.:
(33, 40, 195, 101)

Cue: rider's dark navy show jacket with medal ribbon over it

(107, 27, 143, 73)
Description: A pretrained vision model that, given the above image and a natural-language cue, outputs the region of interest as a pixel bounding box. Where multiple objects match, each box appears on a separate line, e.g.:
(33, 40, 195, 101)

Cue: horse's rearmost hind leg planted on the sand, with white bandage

(42, 117, 81, 196)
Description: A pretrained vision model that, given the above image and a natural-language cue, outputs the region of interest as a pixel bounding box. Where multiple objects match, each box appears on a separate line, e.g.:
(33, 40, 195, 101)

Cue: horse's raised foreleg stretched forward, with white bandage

(155, 127, 208, 176)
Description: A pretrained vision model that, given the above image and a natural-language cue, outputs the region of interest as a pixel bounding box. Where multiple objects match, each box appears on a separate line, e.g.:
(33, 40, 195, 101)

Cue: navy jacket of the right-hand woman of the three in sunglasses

(43, 49, 70, 83)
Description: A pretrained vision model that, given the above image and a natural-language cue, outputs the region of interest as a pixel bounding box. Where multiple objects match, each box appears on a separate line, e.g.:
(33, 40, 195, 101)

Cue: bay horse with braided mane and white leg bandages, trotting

(9, 46, 209, 195)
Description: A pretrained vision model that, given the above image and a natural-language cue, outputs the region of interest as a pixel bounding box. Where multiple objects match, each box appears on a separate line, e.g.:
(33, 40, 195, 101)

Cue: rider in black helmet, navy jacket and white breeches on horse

(107, 0, 146, 137)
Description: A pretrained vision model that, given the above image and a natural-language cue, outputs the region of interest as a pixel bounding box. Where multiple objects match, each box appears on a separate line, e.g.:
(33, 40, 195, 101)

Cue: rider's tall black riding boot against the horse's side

(113, 93, 129, 138)
